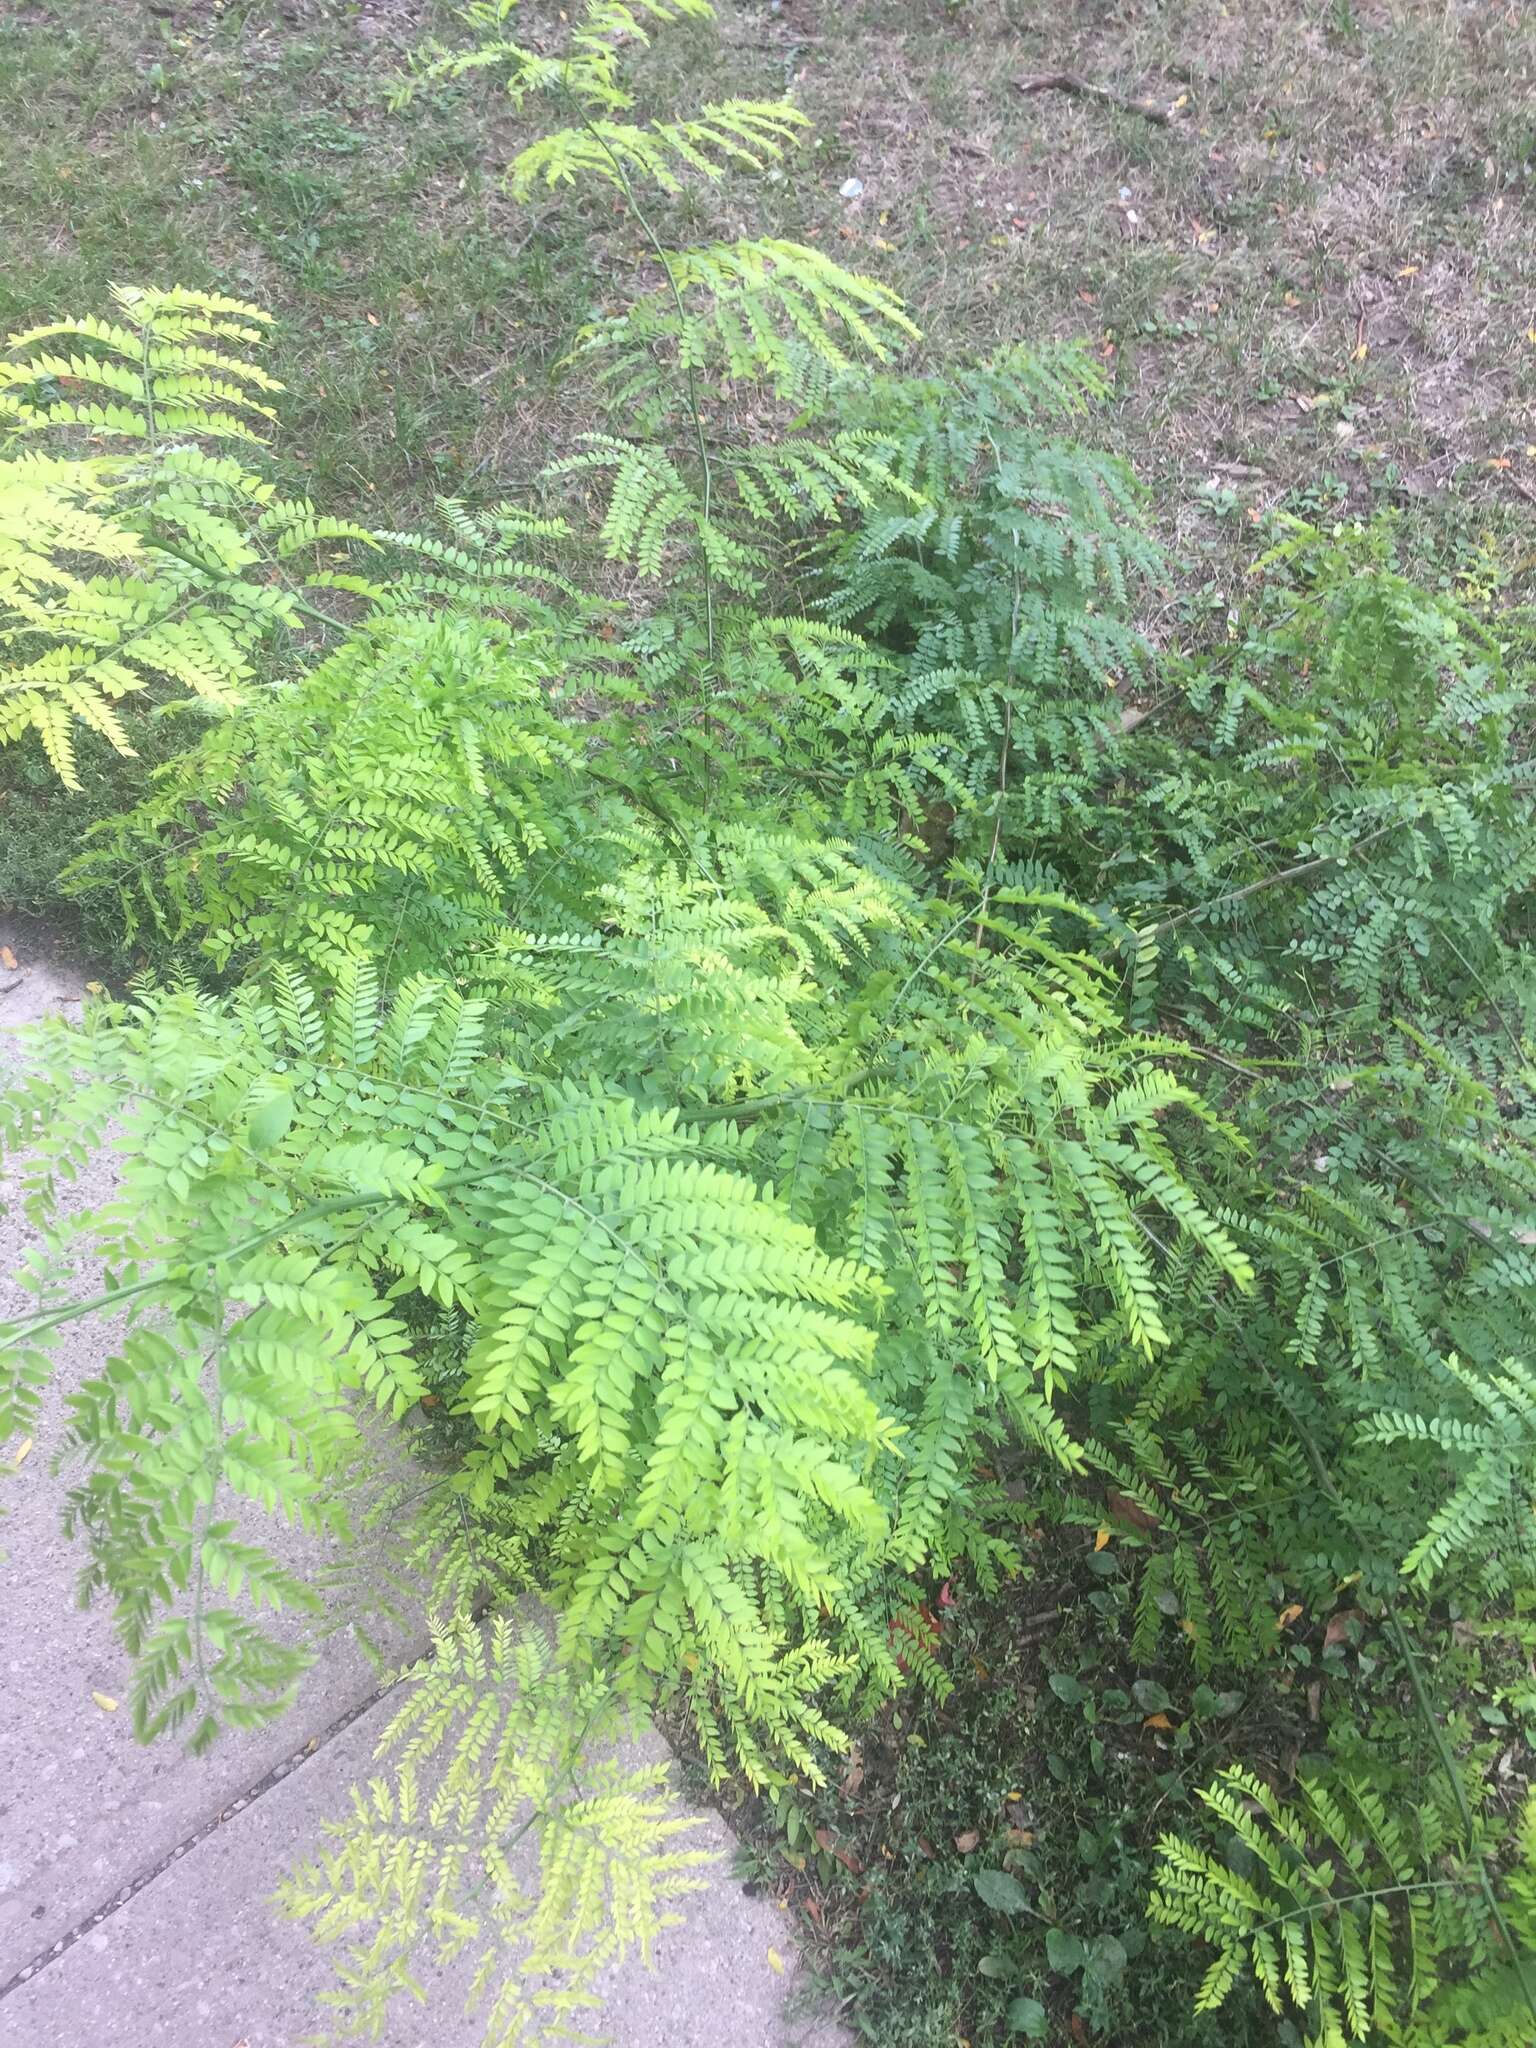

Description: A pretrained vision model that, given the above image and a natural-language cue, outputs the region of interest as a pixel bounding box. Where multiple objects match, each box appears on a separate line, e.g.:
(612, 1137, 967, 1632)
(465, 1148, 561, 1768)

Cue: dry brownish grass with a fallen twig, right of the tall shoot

(724, 0, 1536, 593)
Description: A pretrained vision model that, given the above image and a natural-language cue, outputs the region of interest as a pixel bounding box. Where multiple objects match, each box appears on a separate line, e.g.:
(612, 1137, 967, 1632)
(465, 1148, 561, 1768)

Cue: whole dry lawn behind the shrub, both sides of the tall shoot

(0, 0, 1536, 575)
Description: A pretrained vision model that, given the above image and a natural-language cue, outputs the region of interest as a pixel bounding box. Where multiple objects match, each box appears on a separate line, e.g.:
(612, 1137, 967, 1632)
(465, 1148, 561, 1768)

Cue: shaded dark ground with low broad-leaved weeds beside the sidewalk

(724, 1536, 1307, 2048)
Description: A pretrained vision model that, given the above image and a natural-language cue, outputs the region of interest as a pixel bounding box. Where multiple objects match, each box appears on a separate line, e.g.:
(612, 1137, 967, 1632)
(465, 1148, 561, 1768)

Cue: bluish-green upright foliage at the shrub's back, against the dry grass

(823, 348, 1159, 854)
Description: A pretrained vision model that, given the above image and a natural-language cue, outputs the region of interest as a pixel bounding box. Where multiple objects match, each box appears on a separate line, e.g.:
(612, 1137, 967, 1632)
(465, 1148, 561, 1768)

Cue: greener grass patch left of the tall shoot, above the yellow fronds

(0, 0, 590, 524)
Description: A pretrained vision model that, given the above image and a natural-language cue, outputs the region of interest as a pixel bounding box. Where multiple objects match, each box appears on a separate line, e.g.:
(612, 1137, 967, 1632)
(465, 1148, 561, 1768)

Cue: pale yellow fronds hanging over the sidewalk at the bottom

(279, 1616, 711, 2048)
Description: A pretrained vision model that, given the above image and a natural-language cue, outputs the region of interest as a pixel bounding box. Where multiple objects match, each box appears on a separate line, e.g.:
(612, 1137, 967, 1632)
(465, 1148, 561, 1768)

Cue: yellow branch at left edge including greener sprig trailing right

(0, 285, 577, 788)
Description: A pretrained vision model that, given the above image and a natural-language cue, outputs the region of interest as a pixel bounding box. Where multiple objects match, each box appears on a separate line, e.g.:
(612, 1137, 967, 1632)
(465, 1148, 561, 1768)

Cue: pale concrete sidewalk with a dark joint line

(0, 922, 844, 2048)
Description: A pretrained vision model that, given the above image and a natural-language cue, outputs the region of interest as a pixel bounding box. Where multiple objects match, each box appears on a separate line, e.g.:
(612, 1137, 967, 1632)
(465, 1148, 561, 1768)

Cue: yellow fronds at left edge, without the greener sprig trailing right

(0, 287, 299, 786)
